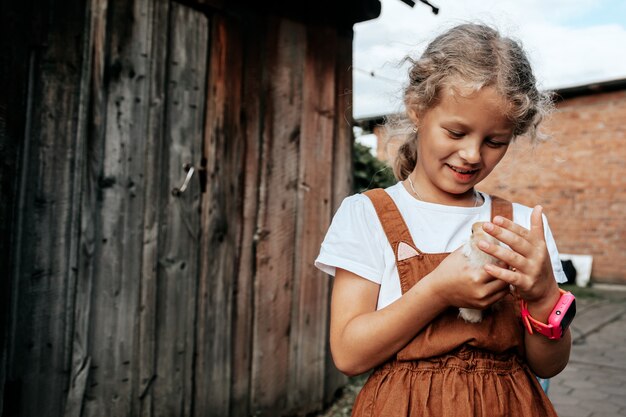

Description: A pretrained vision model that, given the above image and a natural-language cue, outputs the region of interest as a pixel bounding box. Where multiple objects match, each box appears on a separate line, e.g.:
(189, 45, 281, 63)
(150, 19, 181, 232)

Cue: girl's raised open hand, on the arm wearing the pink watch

(478, 206, 559, 306)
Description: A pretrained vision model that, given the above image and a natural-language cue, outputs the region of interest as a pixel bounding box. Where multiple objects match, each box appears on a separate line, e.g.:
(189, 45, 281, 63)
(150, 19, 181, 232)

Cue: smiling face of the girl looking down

(410, 87, 513, 205)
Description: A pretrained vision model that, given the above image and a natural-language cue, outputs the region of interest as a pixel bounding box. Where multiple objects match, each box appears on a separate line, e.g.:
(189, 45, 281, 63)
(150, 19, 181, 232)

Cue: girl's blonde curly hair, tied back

(385, 23, 553, 180)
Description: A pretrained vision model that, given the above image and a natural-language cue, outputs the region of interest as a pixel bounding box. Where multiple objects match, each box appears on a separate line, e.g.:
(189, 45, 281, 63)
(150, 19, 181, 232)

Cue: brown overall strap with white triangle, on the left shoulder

(363, 188, 422, 261)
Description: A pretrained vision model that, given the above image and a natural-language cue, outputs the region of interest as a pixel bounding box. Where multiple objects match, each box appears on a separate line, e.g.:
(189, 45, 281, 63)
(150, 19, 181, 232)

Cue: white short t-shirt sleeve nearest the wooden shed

(315, 194, 385, 284)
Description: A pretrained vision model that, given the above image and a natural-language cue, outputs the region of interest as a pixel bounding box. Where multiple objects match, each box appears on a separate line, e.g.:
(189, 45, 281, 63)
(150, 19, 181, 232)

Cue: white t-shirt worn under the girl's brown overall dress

(315, 182, 567, 309)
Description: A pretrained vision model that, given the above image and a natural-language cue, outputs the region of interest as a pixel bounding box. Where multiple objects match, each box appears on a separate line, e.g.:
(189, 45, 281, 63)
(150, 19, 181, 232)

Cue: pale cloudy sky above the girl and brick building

(353, 0, 626, 119)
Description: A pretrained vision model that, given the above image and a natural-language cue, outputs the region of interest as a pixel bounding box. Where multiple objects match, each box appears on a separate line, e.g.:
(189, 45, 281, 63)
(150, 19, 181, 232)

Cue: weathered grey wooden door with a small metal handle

(74, 0, 209, 417)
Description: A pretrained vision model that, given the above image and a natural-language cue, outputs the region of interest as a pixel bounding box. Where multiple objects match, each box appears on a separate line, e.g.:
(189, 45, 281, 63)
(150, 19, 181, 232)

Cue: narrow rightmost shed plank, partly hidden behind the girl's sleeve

(324, 30, 354, 404)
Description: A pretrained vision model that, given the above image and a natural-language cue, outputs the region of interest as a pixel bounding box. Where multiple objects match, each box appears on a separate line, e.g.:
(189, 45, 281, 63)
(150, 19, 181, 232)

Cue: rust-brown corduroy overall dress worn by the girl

(352, 189, 556, 417)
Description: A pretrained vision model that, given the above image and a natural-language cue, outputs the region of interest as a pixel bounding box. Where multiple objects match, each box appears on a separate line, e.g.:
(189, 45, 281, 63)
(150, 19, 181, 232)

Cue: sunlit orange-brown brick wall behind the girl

(372, 90, 626, 284)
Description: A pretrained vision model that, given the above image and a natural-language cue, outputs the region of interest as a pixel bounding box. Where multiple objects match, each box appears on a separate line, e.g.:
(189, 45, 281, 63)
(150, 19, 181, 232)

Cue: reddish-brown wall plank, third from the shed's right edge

(251, 16, 306, 415)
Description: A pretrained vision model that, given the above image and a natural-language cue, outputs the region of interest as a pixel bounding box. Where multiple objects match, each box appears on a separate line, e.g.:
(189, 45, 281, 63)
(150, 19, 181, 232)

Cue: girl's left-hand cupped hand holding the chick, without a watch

(428, 247, 509, 310)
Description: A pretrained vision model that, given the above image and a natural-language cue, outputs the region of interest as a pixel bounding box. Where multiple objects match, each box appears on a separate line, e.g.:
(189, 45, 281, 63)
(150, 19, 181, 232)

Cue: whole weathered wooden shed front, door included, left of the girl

(0, 0, 352, 417)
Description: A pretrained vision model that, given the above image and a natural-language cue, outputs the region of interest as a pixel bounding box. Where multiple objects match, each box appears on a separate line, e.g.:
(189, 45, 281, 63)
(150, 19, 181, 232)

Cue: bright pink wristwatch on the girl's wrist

(520, 288, 576, 340)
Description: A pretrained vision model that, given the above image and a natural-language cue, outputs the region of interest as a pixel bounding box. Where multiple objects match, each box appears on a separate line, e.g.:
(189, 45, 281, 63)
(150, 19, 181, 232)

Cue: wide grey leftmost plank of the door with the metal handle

(82, 0, 152, 416)
